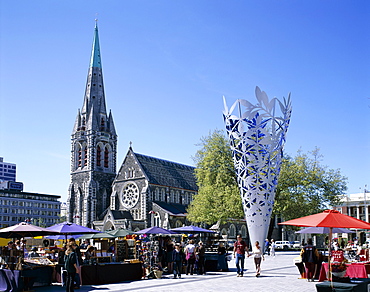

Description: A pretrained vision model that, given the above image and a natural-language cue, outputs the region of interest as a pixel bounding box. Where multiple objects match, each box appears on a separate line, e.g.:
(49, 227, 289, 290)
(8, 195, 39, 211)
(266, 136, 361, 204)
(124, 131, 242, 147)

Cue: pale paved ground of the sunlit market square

(34, 251, 324, 292)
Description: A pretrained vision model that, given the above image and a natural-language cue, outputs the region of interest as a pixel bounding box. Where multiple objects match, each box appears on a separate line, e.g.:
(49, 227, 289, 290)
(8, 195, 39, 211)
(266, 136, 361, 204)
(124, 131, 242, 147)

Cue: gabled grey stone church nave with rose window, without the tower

(94, 147, 197, 230)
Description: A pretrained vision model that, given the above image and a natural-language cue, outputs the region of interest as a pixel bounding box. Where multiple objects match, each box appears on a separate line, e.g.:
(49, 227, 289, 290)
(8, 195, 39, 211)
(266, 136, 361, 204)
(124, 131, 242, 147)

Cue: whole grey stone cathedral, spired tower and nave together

(67, 24, 197, 231)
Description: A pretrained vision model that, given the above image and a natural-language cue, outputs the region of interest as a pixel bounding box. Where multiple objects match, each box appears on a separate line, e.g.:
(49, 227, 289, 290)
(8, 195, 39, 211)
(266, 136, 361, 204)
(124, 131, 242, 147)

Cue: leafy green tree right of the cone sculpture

(274, 148, 347, 220)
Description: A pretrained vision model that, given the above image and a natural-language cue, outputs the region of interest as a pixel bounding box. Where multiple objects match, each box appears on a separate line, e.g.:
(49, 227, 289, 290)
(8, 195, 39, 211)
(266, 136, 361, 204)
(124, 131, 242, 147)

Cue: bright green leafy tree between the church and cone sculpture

(188, 130, 244, 224)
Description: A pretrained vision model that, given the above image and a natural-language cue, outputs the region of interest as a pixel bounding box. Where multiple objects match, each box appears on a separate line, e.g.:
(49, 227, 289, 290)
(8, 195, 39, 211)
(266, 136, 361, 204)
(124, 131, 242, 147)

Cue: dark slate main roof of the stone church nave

(135, 153, 198, 191)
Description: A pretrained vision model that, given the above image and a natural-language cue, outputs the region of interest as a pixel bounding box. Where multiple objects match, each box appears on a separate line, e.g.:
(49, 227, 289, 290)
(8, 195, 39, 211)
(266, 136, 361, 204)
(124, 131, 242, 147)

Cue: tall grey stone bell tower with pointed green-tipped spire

(67, 22, 117, 227)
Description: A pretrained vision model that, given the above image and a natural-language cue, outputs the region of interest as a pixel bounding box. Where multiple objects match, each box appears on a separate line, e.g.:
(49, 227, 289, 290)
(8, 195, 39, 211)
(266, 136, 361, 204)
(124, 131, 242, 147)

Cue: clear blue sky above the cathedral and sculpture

(0, 0, 370, 201)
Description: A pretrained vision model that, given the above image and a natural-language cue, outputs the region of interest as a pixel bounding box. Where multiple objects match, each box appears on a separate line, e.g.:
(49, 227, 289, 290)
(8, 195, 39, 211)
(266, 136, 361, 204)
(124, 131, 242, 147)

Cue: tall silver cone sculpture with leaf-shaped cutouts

(223, 87, 292, 251)
